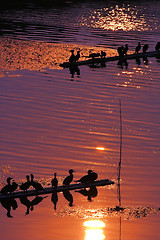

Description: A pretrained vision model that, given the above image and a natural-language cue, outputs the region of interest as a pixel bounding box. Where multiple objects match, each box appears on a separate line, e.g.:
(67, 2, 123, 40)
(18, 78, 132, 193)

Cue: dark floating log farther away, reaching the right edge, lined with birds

(60, 51, 160, 68)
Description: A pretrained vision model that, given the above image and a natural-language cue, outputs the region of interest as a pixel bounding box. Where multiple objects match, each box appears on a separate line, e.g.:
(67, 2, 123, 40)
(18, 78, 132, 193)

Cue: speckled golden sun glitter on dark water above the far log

(81, 5, 150, 31)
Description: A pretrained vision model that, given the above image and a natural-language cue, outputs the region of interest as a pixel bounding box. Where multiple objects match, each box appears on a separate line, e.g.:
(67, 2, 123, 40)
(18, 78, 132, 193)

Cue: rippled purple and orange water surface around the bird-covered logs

(0, 1, 160, 240)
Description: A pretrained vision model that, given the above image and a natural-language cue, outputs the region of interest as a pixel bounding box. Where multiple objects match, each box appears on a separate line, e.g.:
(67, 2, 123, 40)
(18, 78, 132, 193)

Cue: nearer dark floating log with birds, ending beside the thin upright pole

(0, 179, 114, 200)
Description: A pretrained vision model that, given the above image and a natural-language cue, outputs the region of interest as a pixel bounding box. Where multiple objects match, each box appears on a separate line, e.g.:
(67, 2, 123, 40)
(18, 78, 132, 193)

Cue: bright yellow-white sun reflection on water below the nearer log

(83, 220, 105, 240)
